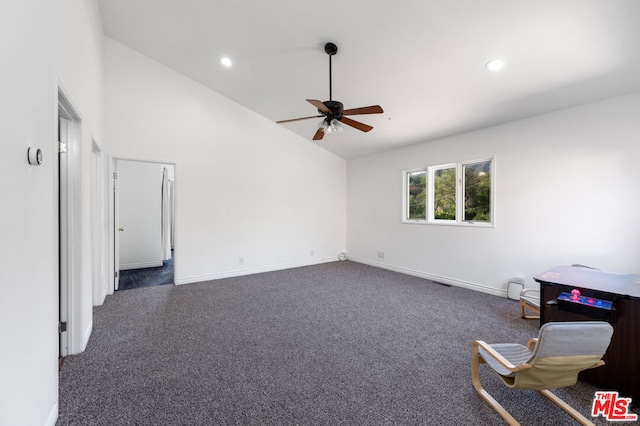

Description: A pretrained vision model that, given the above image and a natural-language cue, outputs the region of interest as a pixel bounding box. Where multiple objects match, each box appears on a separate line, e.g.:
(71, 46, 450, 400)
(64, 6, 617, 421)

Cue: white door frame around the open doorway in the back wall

(108, 155, 179, 294)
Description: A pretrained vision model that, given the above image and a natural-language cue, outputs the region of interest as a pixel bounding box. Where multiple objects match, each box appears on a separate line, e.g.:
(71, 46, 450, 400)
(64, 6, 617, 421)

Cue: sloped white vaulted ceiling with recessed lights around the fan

(99, 0, 640, 158)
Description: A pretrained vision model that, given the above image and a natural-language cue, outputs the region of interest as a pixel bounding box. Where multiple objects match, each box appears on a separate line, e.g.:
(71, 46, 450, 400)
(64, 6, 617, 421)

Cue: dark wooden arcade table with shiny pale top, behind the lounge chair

(534, 266, 640, 404)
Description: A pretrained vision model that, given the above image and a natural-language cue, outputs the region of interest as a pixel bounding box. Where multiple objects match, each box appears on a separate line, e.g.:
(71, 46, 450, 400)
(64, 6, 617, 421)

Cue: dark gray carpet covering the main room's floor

(57, 262, 607, 425)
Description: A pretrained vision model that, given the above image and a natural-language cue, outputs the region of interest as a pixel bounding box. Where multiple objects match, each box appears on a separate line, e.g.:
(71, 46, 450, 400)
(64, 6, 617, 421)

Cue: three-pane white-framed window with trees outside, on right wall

(404, 158, 495, 226)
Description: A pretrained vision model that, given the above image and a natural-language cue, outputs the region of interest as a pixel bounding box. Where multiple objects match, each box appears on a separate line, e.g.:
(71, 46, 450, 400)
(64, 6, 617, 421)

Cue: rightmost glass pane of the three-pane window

(463, 161, 491, 222)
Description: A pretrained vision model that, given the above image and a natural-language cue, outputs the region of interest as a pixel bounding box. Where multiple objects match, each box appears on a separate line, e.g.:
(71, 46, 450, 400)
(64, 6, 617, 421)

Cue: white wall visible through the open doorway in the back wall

(117, 160, 162, 270)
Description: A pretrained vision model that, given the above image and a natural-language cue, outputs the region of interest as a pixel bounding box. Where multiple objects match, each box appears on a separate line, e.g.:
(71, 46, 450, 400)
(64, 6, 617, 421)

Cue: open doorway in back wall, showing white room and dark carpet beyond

(113, 159, 175, 290)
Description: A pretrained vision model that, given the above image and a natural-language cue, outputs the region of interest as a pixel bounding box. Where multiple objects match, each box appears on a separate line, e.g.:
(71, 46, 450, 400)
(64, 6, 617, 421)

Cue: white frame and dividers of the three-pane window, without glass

(402, 156, 496, 228)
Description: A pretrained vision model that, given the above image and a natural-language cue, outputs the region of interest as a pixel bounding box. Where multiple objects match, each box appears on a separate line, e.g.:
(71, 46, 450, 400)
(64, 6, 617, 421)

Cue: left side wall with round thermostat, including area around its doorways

(0, 0, 103, 425)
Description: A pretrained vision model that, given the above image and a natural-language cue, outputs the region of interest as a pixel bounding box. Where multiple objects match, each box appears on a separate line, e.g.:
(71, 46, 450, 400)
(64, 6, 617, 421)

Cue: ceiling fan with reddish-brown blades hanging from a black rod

(276, 43, 384, 141)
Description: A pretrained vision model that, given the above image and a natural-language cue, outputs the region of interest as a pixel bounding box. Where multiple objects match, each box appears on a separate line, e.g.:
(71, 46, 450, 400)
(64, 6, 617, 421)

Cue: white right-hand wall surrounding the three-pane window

(347, 93, 640, 294)
